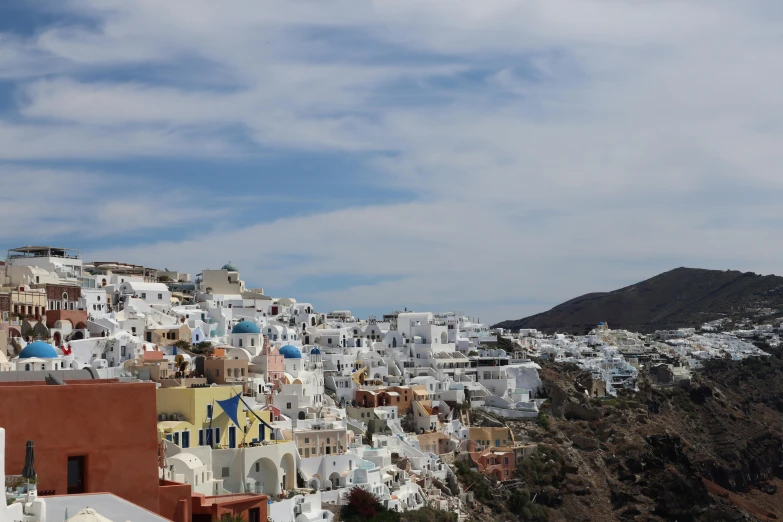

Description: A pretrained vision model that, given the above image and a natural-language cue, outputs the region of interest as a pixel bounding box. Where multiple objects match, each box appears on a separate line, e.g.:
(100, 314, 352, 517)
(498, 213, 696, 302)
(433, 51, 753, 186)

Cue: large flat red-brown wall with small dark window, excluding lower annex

(0, 381, 159, 513)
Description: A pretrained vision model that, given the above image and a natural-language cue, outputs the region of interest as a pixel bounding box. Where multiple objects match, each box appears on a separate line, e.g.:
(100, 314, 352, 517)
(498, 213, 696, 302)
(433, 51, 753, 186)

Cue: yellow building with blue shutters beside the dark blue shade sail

(157, 386, 273, 448)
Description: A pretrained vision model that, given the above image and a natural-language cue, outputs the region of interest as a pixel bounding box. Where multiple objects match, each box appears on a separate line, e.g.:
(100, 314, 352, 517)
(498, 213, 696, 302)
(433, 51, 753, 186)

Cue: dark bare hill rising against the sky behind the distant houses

(495, 268, 783, 334)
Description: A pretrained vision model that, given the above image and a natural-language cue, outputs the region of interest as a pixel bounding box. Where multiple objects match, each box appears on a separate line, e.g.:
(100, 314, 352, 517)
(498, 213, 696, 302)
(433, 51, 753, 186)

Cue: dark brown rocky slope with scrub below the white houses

(462, 350, 783, 522)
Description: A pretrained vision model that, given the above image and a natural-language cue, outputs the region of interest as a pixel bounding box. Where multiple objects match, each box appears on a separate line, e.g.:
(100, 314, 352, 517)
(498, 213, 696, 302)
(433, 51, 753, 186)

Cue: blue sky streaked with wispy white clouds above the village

(0, 0, 783, 323)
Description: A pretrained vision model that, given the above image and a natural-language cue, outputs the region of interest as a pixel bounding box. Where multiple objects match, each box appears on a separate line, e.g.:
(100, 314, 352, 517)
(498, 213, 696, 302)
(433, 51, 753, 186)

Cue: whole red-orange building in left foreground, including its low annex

(0, 379, 267, 522)
